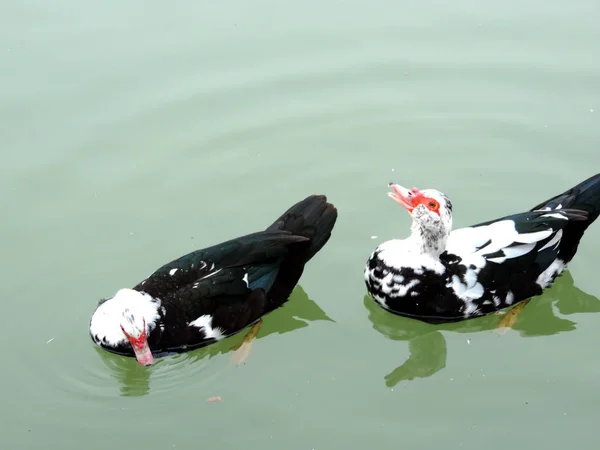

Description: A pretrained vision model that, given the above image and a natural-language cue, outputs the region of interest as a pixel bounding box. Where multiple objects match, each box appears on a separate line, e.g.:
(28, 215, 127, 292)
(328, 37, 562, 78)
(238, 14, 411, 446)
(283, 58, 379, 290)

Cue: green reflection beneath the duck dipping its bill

(94, 285, 333, 397)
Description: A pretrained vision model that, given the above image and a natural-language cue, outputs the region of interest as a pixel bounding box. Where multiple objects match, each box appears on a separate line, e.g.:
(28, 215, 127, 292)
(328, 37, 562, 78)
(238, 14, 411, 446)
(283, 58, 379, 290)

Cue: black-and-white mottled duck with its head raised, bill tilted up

(364, 174, 600, 323)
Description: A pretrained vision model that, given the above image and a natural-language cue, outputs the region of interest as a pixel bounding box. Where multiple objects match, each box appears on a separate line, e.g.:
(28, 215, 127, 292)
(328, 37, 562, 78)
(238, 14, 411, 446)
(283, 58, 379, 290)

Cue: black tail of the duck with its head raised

(531, 173, 600, 263)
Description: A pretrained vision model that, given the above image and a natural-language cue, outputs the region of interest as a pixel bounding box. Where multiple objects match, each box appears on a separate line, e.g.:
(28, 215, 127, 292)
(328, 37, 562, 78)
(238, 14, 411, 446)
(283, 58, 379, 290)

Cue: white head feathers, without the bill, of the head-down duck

(90, 289, 161, 347)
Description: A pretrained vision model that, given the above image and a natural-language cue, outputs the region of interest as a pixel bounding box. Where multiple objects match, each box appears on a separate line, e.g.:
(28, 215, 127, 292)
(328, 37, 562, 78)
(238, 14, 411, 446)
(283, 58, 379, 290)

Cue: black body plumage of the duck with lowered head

(94, 195, 337, 355)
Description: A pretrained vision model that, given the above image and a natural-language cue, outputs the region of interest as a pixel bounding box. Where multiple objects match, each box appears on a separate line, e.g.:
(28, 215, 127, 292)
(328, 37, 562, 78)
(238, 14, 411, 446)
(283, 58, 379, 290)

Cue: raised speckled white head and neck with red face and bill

(388, 183, 452, 257)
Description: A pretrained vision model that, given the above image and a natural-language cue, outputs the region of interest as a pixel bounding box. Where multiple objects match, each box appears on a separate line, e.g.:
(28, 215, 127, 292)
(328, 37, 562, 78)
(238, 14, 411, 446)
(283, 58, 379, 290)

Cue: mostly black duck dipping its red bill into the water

(89, 195, 337, 365)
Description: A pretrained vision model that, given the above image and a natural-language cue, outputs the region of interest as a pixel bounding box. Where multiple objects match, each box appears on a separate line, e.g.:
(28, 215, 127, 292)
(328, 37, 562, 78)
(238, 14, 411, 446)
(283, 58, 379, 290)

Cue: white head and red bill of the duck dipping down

(90, 289, 160, 366)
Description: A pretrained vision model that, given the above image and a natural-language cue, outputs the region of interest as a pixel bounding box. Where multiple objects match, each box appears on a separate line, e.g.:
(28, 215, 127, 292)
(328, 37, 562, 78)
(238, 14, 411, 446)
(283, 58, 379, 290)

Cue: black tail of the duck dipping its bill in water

(267, 195, 337, 262)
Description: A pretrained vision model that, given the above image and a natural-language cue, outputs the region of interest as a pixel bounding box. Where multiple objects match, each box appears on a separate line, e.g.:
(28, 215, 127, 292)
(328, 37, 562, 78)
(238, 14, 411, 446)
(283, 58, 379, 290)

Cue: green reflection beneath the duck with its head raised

(364, 271, 600, 387)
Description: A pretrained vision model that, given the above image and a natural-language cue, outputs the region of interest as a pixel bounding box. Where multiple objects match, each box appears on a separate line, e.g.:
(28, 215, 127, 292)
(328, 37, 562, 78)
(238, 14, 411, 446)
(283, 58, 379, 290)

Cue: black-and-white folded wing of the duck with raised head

(440, 209, 588, 314)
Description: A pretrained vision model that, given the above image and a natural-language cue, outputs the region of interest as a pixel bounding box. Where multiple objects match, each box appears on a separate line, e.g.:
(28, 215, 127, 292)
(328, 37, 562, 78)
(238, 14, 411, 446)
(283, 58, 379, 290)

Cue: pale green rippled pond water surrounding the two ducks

(0, 0, 600, 450)
